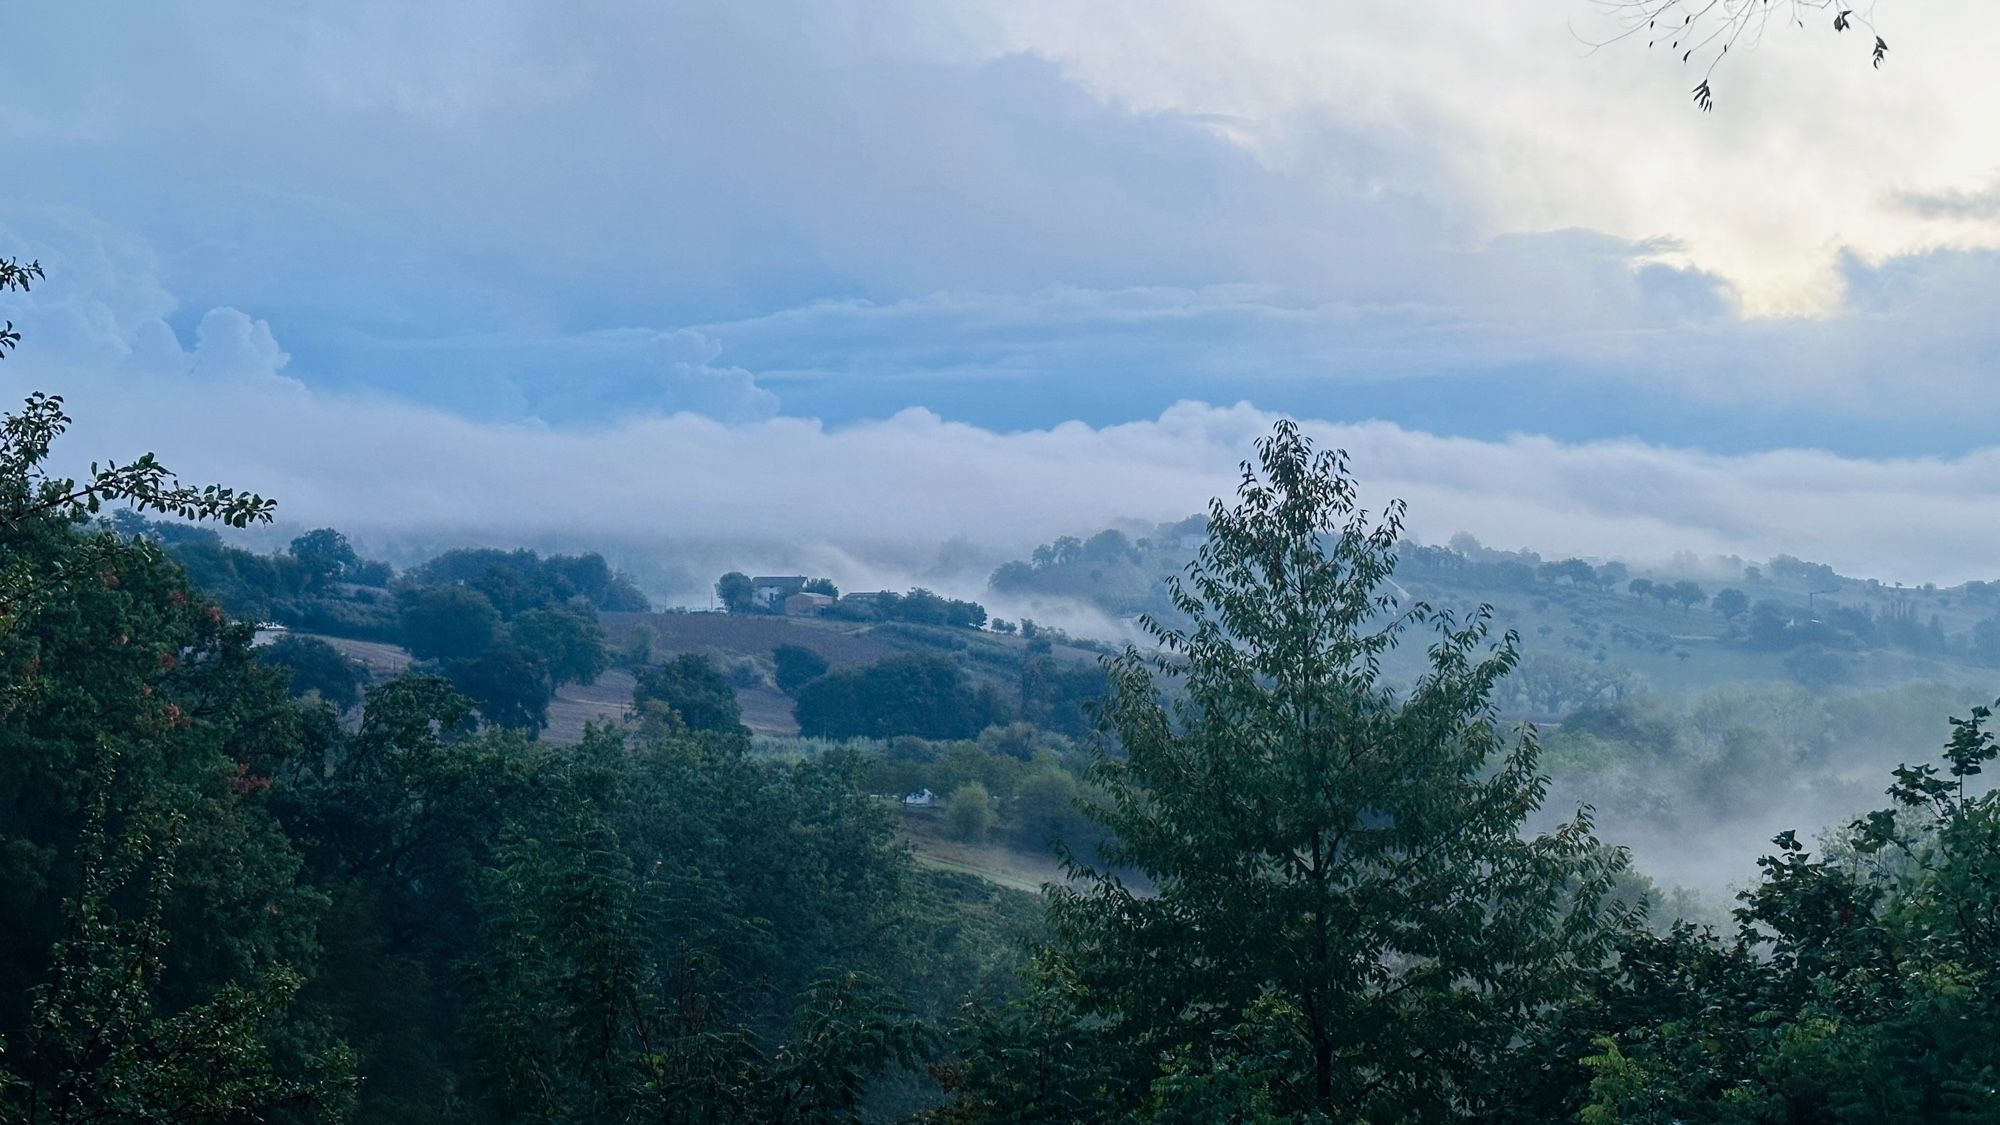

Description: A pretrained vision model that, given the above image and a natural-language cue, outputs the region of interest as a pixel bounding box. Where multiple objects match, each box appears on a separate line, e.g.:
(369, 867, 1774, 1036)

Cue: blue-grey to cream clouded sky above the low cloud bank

(11, 0, 2000, 438)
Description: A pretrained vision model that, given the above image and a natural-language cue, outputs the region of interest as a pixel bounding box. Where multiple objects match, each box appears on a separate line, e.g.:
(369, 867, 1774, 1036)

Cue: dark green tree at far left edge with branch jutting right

(0, 260, 340, 1123)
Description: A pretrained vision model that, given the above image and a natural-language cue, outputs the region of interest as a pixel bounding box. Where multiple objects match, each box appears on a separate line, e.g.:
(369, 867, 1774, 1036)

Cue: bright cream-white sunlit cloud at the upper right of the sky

(960, 0, 2000, 312)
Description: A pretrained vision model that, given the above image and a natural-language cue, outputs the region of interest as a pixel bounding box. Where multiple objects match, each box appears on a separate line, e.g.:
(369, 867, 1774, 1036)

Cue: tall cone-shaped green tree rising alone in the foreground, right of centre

(1050, 422, 1622, 1121)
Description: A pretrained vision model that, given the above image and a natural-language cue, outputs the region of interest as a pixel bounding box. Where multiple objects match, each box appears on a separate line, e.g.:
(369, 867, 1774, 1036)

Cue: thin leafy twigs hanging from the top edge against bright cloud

(1594, 0, 1888, 112)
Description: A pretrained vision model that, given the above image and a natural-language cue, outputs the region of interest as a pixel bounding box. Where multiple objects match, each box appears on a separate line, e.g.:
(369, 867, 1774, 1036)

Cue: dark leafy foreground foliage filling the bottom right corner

(1560, 707, 2000, 1125)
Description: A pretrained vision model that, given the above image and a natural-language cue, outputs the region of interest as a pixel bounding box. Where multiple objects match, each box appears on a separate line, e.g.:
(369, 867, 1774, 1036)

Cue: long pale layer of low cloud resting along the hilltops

(19, 286, 2000, 593)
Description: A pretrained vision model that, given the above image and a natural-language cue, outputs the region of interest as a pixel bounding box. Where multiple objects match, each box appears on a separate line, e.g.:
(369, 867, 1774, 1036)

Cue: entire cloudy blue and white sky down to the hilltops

(0, 0, 2000, 589)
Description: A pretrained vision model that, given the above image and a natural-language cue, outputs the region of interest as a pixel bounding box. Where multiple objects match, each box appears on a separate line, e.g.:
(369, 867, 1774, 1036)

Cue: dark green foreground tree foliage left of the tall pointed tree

(0, 272, 1008, 1125)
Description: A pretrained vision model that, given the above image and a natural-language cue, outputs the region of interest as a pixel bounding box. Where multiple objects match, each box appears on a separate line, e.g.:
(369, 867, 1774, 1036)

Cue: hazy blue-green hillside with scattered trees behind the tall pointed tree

(990, 520, 2000, 719)
